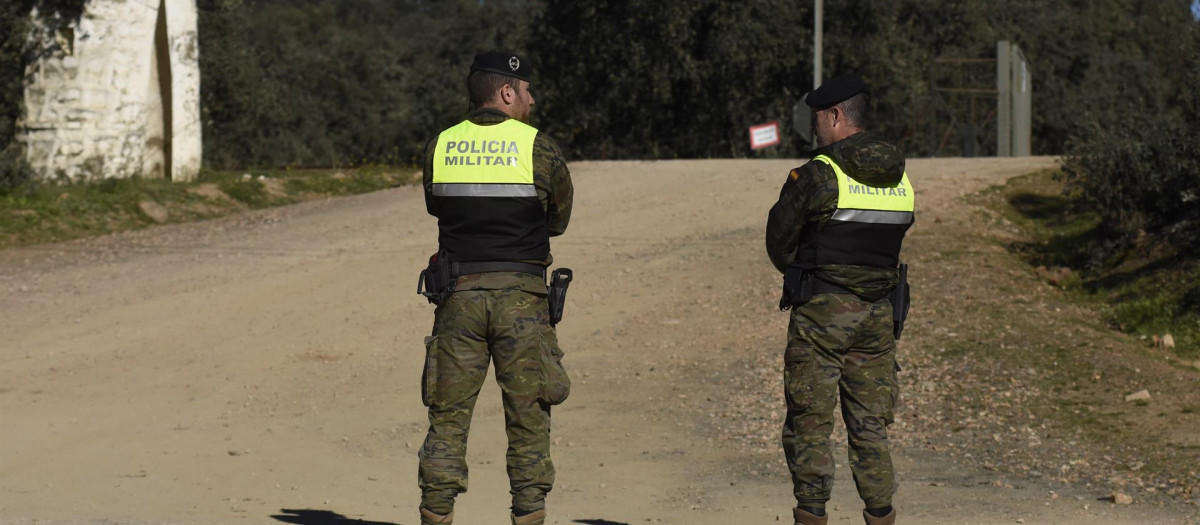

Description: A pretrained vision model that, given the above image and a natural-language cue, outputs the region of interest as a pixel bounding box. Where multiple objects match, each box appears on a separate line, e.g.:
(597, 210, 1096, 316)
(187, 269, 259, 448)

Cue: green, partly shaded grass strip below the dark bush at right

(978, 170, 1200, 360)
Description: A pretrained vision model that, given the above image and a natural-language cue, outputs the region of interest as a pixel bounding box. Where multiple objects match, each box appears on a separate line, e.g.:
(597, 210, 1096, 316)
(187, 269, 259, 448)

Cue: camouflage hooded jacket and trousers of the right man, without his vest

(767, 132, 905, 508)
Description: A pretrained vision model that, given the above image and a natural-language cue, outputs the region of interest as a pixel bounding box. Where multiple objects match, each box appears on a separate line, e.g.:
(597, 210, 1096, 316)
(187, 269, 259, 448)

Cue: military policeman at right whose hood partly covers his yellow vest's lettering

(767, 74, 913, 525)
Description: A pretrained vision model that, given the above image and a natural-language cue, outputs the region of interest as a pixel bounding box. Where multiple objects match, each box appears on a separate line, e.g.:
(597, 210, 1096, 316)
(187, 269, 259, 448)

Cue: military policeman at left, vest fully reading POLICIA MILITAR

(418, 53, 572, 525)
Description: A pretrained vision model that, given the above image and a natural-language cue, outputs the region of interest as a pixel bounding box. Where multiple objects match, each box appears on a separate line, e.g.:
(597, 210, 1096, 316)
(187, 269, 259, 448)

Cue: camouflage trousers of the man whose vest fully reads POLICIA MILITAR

(418, 289, 570, 514)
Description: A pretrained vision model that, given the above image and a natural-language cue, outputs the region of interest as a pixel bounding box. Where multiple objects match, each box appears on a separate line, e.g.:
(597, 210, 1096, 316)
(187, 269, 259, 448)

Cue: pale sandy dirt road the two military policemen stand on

(0, 158, 1200, 525)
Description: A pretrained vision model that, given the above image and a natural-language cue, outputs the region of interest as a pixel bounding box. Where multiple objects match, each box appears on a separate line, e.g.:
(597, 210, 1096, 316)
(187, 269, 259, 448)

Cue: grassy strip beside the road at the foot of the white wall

(0, 167, 414, 249)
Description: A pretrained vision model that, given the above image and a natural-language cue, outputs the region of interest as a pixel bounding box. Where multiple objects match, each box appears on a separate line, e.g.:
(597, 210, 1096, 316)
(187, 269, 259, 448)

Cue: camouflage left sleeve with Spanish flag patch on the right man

(767, 162, 838, 272)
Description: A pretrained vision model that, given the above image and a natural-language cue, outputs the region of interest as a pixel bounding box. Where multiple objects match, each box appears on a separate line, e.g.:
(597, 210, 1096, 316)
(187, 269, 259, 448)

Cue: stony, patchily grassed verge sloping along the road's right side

(911, 170, 1200, 503)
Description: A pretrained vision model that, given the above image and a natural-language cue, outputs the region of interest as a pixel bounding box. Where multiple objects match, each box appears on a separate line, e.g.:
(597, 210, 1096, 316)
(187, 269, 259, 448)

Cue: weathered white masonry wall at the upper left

(20, 0, 200, 180)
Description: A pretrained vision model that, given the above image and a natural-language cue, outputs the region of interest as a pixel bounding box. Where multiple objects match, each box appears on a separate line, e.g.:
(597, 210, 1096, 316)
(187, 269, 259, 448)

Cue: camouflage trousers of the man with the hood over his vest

(784, 294, 899, 508)
